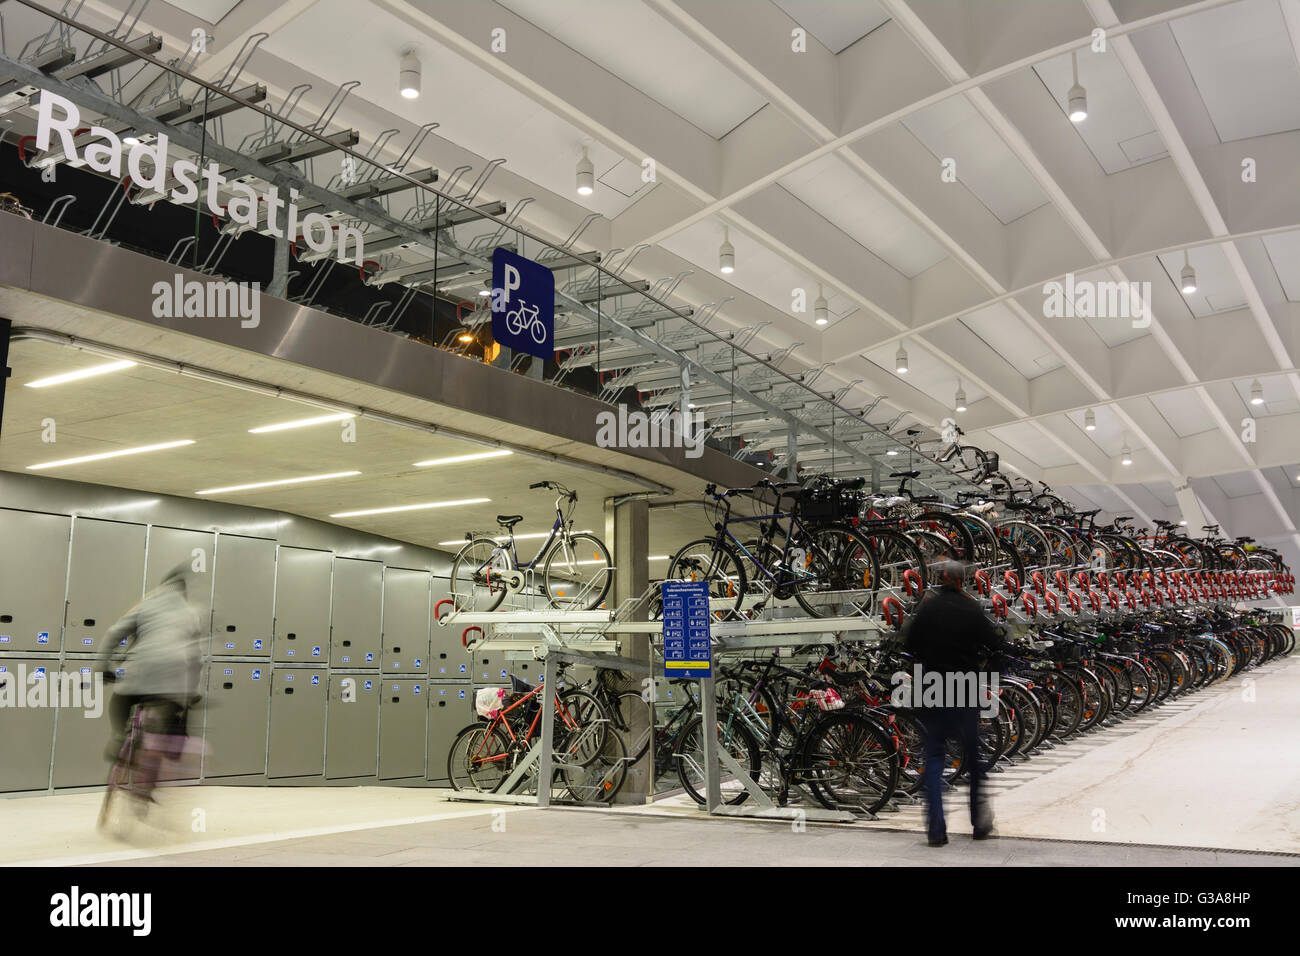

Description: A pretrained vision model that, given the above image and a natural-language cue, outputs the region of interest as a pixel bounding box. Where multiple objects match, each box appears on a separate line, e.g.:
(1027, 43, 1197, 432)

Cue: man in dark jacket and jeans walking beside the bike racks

(906, 561, 1005, 847)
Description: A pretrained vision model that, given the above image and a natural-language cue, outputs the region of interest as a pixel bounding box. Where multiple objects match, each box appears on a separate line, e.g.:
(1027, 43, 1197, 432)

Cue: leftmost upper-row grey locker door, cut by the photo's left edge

(0, 509, 72, 653)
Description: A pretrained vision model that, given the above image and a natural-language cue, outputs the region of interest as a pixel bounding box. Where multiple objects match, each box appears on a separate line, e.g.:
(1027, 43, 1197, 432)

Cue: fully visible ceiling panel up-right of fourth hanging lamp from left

(779, 155, 948, 278)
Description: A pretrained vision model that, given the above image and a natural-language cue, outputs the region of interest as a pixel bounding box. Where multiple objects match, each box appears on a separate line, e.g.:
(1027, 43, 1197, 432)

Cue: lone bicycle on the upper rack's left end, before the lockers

(451, 481, 614, 611)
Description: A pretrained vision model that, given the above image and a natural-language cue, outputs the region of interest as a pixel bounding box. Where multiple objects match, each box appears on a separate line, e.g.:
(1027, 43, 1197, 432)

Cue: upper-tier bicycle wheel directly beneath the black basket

(790, 527, 880, 618)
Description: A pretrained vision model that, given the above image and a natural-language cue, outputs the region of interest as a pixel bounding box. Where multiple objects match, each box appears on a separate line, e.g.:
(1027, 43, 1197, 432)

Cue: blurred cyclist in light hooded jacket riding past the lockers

(99, 562, 203, 761)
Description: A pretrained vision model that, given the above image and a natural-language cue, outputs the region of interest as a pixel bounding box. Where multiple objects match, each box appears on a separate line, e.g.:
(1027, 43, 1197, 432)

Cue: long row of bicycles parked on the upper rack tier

(666, 471, 1295, 623)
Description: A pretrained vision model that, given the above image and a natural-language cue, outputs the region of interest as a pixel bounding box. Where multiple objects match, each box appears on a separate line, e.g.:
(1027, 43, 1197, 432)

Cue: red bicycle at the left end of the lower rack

(447, 678, 628, 804)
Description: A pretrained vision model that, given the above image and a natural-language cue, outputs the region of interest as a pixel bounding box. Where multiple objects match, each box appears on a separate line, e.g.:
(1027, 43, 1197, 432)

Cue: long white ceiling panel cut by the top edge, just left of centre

(497, 0, 766, 139)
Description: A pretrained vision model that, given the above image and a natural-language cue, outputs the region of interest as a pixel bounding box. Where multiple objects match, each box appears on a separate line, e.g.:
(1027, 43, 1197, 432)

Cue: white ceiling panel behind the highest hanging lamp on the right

(1034, 48, 1166, 174)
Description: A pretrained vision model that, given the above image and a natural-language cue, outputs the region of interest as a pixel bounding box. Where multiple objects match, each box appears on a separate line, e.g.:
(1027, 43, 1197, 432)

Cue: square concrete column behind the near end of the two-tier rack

(605, 497, 654, 804)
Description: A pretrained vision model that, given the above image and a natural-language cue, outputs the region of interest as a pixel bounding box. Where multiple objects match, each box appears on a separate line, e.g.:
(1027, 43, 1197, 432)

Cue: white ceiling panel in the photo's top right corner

(1169, 0, 1300, 143)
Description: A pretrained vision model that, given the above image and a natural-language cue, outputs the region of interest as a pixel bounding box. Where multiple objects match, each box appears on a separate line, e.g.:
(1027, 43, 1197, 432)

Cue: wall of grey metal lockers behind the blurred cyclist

(0, 472, 517, 793)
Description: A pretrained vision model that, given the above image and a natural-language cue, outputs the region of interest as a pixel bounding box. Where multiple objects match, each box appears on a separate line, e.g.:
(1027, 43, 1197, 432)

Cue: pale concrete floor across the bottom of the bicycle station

(0, 659, 1300, 866)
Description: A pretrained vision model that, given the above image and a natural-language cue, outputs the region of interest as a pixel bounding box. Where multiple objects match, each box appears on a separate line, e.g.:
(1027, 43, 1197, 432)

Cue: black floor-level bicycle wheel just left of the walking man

(801, 711, 898, 814)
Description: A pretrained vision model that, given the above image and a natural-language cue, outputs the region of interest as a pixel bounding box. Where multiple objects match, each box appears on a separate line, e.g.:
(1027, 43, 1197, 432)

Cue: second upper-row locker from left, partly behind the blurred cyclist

(64, 518, 144, 653)
